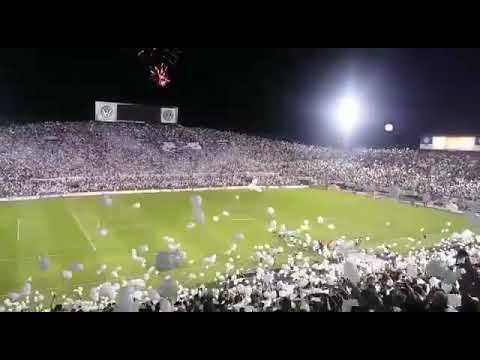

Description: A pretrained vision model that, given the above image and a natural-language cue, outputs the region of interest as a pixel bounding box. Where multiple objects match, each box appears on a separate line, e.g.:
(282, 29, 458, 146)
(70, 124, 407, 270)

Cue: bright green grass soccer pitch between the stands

(0, 189, 467, 302)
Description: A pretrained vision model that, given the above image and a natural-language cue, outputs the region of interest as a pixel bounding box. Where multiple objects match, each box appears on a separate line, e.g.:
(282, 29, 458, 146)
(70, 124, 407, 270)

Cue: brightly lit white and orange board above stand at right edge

(420, 136, 480, 151)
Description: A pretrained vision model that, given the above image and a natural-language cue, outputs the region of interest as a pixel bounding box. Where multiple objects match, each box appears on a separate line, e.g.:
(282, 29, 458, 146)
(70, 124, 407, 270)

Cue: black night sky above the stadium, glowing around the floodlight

(0, 48, 480, 146)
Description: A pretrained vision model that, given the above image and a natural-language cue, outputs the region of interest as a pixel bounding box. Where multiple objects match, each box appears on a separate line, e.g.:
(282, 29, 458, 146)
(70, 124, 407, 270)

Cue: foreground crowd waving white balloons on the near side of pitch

(7, 225, 480, 312)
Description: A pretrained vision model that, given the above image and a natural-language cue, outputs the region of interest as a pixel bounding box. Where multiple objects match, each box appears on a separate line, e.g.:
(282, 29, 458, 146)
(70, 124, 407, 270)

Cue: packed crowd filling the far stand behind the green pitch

(0, 123, 480, 202)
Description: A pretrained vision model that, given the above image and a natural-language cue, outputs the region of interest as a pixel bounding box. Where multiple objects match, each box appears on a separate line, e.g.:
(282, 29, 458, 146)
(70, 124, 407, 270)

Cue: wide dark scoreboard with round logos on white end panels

(95, 101, 178, 124)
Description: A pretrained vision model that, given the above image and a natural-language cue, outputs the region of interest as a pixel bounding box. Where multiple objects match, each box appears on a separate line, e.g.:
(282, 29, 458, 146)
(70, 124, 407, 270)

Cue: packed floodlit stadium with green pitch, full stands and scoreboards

(0, 48, 480, 312)
